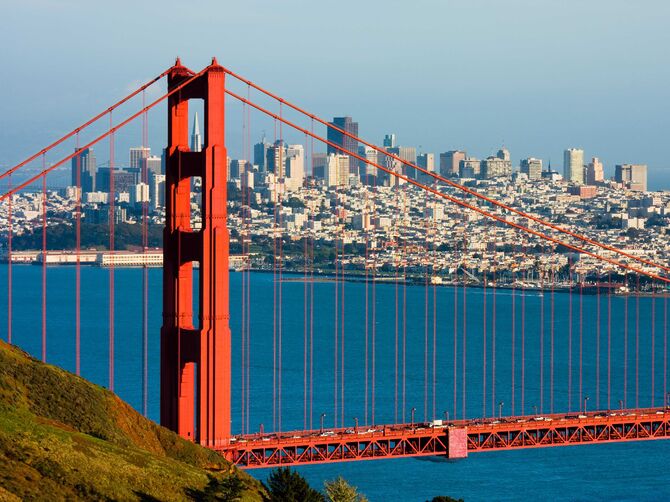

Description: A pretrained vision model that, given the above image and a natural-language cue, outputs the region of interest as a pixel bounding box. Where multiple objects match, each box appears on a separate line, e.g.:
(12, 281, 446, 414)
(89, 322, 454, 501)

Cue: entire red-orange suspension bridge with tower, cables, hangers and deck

(0, 59, 670, 467)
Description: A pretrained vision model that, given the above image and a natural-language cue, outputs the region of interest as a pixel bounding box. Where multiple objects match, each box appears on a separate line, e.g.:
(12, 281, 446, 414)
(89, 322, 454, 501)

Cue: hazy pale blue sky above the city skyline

(0, 0, 670, 189)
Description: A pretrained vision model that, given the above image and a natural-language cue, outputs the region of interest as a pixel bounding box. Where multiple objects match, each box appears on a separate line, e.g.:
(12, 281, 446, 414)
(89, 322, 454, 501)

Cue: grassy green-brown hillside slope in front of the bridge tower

(0, 341, 261, 501)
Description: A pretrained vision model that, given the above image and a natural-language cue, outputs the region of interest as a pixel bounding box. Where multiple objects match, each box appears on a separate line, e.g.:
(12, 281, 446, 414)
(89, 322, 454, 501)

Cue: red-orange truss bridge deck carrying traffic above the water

(219, 408, 670, 468)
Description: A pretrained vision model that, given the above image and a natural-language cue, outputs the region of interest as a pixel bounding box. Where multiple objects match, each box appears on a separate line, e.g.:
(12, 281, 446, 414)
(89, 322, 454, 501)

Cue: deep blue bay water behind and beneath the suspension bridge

(0, 265, 670, 501)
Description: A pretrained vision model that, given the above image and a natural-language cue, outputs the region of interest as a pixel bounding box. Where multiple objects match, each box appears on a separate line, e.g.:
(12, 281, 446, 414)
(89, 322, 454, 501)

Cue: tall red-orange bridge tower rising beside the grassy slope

(161, 59, 231, 447)
